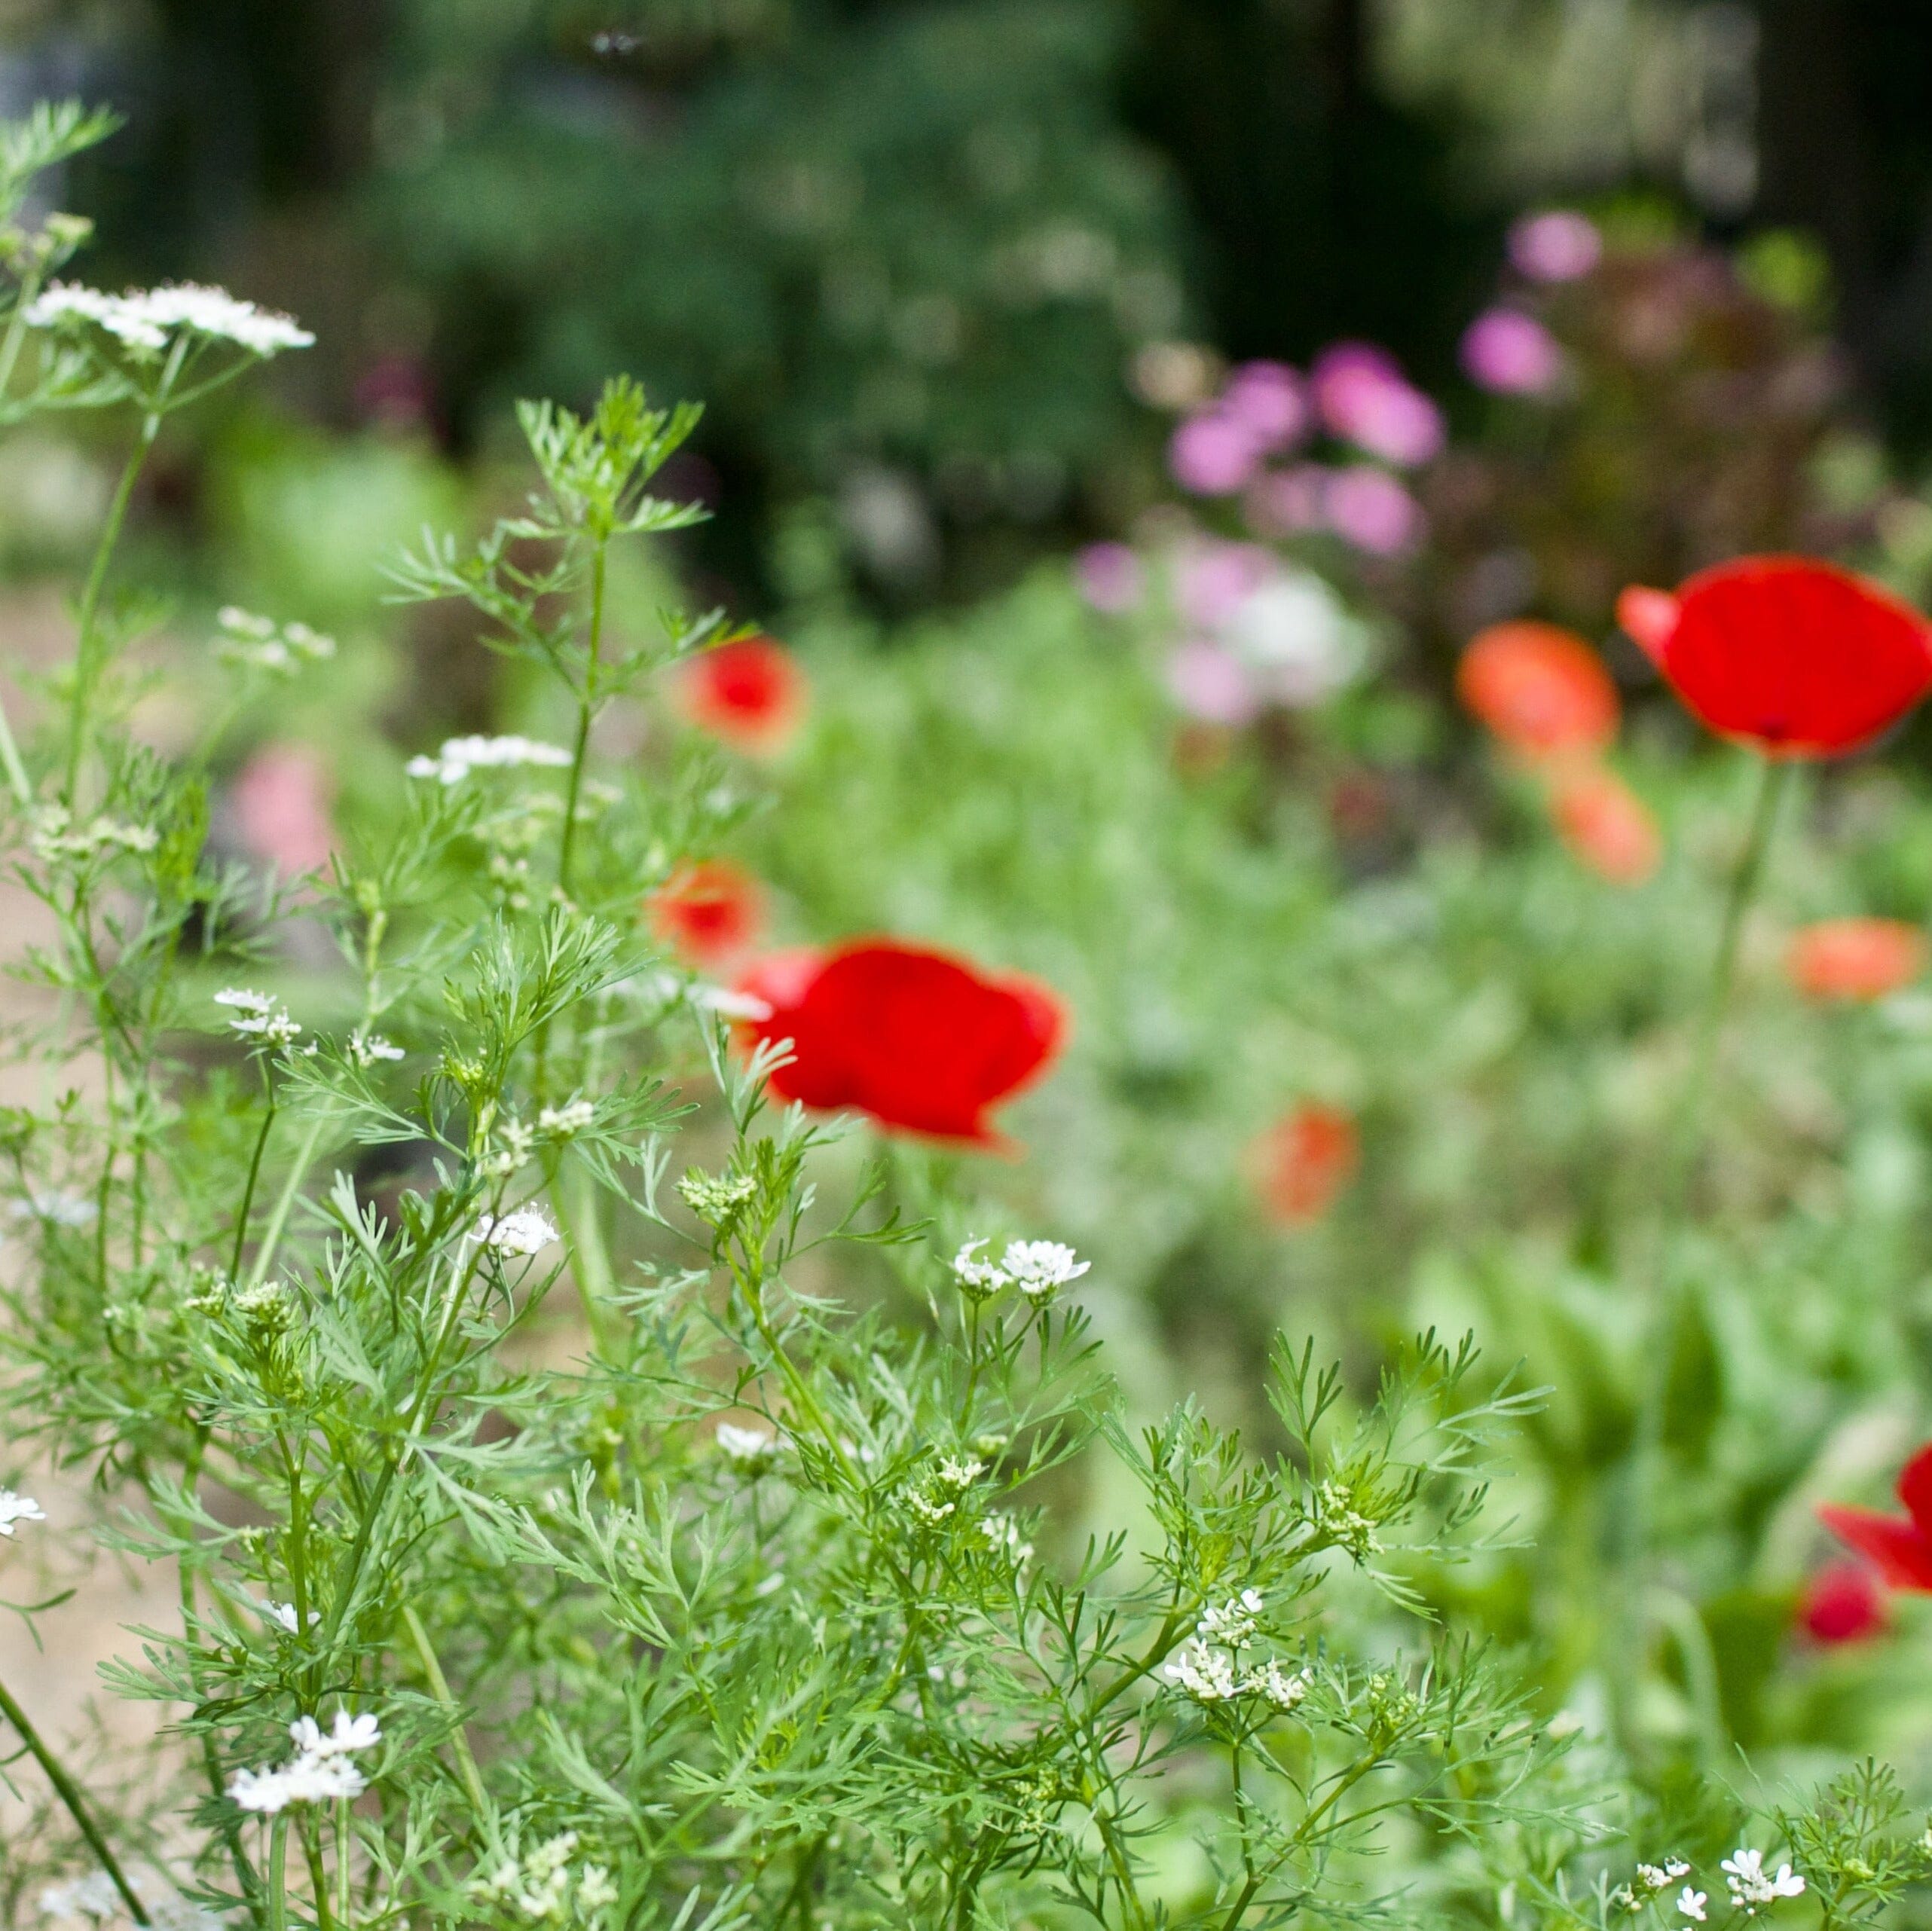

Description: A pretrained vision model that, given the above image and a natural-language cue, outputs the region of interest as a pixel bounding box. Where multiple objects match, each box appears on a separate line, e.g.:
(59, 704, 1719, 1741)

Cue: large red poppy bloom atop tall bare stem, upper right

(1617, 556, 1932, 757)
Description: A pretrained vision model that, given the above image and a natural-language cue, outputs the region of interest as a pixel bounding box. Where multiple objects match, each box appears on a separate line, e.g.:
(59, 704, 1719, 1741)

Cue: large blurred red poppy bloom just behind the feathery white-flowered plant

(740, 939, 1066, 1147)
